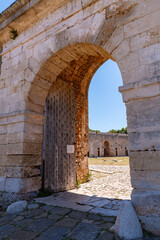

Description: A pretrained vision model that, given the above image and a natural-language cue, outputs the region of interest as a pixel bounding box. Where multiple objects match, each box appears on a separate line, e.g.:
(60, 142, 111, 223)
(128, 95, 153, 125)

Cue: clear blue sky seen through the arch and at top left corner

(0, 0, 127, 132)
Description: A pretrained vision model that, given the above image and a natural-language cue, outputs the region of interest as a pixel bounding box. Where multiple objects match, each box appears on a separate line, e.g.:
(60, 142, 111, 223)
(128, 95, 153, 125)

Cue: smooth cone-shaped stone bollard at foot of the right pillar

(112, 201, 143, 240)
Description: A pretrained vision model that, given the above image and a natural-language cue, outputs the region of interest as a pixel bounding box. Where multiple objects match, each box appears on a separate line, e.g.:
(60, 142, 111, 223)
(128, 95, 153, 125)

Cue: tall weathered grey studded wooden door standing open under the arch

(42, 80, 76, 192)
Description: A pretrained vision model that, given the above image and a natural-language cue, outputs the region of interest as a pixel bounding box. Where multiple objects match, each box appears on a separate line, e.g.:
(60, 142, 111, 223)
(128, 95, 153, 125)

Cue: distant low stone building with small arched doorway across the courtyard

(88, 132, 128, 157)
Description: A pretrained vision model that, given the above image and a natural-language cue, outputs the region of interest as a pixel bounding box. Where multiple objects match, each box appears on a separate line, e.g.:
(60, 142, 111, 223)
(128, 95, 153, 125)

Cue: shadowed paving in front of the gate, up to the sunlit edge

(0, 192, 158, 240)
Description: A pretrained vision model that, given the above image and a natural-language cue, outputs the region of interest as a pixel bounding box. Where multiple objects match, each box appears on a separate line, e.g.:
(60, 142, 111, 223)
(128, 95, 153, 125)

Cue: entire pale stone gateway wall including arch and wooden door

(0, 0, 160, 235)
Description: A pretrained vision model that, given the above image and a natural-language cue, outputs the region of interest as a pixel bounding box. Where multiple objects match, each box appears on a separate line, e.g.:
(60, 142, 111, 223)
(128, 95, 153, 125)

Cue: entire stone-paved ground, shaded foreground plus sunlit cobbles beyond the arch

(0, 162, 160, 240)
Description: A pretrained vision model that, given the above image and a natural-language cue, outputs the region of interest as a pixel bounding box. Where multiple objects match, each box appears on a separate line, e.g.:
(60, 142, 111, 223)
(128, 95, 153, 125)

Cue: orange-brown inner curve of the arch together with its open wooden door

(28, 44, 128, 192)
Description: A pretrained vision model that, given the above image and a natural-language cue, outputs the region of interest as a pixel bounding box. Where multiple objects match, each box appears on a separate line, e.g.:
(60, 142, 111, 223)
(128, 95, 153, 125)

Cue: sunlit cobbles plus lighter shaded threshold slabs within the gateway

(36, 165, 132, 216)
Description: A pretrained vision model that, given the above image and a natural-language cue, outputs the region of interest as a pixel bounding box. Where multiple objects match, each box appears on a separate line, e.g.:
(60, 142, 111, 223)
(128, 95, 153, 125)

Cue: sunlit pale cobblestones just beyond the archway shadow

(80, 165, 132, 200)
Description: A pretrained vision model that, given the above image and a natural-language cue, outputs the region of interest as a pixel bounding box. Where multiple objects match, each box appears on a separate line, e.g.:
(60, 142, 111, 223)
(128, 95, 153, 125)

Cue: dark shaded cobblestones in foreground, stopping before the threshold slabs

(0, 203, 160, 240)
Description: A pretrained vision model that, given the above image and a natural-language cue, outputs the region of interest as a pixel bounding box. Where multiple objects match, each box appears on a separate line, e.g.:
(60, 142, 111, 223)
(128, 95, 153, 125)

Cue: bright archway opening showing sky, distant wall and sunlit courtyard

(87, 60, 132, 206)
